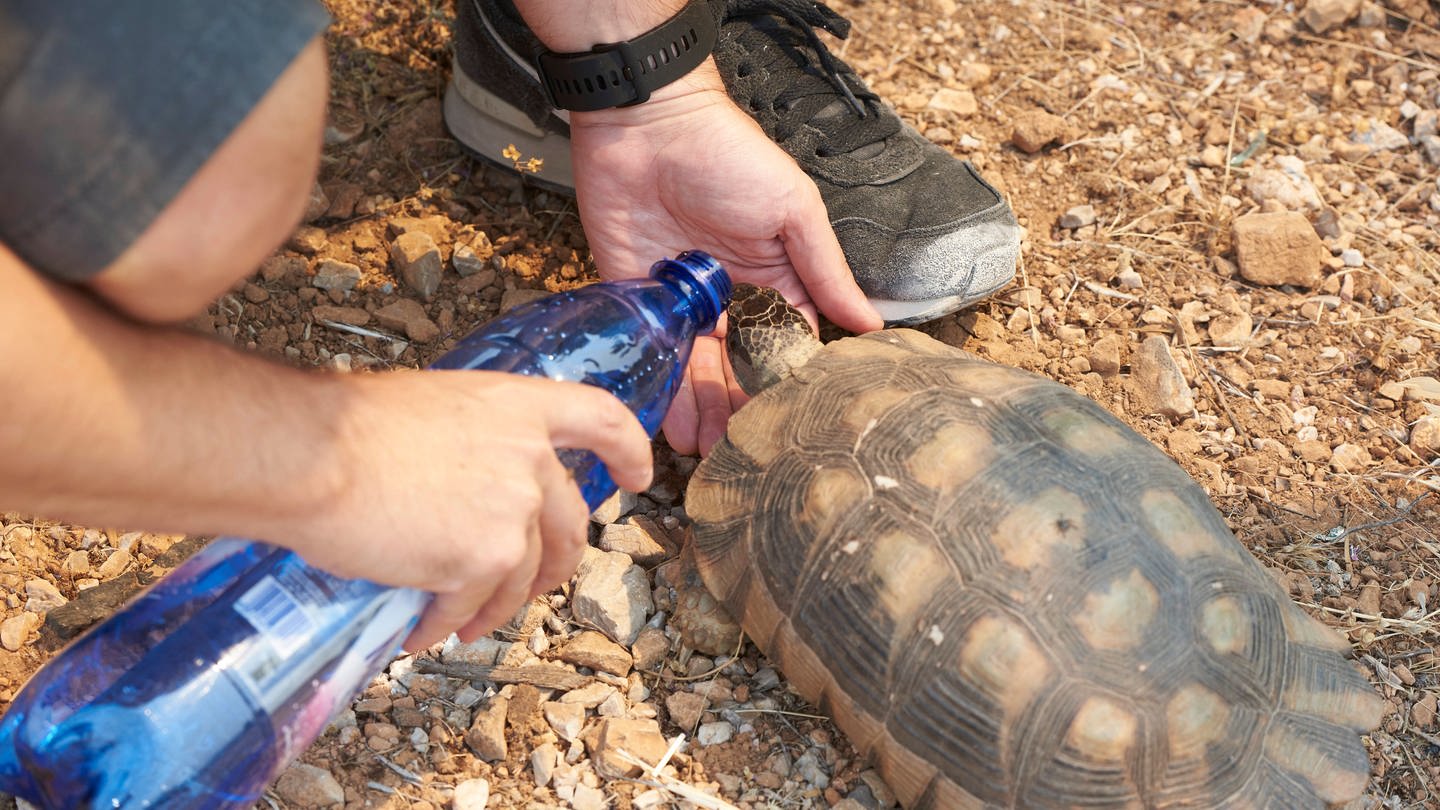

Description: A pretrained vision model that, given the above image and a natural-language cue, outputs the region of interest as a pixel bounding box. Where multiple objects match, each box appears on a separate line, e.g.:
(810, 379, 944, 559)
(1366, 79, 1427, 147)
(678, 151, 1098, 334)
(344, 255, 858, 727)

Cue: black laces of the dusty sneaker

(724, 0, 900, 157)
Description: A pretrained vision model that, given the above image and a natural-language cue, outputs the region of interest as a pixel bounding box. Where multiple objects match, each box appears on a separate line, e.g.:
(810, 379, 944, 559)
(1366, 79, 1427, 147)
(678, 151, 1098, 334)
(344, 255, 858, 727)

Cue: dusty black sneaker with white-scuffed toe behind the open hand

(445, 0, 1020, 326)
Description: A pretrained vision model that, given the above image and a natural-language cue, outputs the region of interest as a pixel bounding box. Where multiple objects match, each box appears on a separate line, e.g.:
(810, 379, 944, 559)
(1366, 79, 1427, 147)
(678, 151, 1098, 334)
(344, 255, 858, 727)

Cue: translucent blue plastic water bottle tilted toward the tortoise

(0, 251, 730, 810)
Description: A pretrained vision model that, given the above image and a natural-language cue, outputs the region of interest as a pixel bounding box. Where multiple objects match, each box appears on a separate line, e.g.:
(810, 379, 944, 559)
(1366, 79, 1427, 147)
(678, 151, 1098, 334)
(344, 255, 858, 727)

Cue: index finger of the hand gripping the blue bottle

(536, 380, 654, 491)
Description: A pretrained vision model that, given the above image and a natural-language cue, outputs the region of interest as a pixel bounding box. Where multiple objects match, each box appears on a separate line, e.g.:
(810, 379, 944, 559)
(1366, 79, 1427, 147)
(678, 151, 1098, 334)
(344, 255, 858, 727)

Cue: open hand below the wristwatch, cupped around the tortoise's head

(570, 71, 881, 453)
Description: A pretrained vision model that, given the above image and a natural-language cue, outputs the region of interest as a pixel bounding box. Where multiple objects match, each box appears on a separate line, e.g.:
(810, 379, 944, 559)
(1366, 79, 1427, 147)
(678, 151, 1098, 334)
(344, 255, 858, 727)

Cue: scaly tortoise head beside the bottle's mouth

(726, 284, 821, 396)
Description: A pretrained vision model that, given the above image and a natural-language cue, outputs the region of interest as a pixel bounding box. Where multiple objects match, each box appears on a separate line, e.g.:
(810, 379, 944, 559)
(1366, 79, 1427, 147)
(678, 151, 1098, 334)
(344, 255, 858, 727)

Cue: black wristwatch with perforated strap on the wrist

(536, 0, 716, 112)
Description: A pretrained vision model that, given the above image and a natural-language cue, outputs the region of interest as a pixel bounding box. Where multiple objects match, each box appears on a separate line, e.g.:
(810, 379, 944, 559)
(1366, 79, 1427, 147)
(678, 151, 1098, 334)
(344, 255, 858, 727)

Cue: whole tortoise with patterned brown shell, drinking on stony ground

(672, 285, 1382, 810)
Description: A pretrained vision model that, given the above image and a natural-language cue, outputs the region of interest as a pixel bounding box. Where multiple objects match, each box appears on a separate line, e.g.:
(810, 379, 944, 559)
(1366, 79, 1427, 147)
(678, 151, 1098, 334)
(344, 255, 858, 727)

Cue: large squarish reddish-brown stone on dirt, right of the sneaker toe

(1234, 212, 1329, 288)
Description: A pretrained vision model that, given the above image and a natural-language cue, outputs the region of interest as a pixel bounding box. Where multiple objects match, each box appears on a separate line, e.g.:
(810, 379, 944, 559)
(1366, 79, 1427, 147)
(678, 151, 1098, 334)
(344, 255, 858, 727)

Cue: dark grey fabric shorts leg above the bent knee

(0, 0, 330, 281)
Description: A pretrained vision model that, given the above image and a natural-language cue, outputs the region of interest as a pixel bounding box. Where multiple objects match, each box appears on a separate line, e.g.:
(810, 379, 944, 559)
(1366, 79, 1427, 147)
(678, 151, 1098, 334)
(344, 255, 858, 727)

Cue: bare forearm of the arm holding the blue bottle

(0, 246, 344, 533)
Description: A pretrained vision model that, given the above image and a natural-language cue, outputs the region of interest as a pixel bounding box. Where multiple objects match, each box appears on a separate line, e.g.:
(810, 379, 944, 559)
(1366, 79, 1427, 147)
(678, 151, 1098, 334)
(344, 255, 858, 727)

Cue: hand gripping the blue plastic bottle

(282, 370, 651, 650)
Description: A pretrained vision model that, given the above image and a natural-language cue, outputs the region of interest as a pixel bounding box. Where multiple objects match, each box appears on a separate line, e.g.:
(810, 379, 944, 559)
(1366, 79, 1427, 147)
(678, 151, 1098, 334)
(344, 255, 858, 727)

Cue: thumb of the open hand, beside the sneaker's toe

(782, 184, 884, 331)
